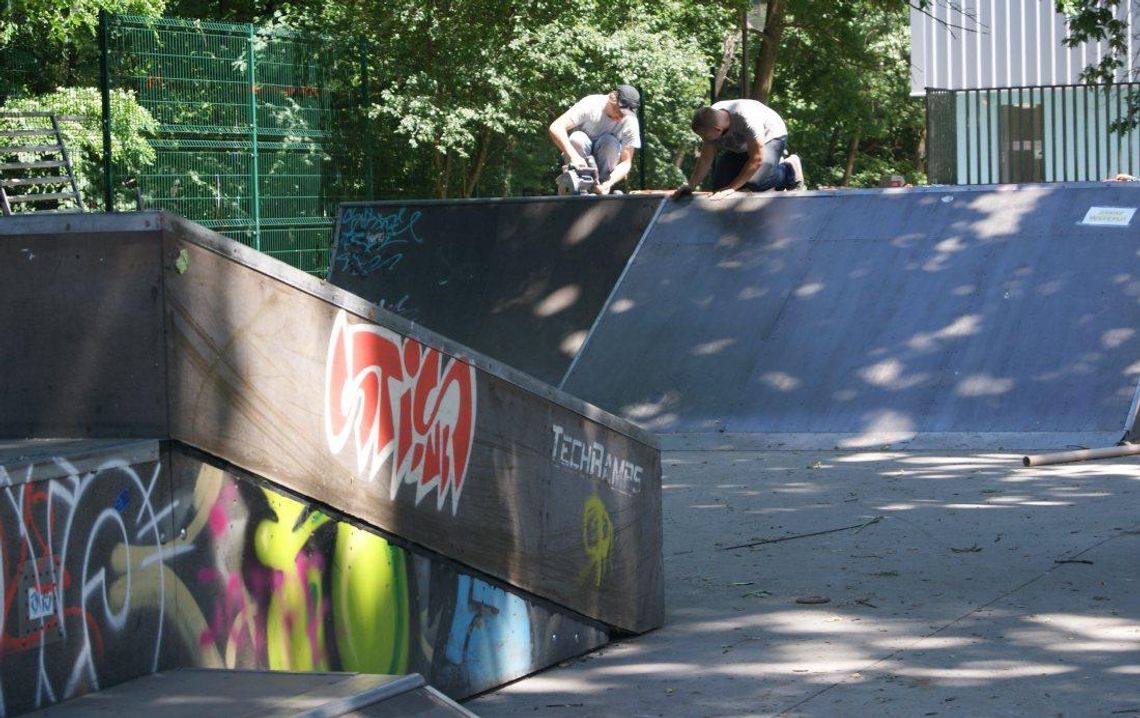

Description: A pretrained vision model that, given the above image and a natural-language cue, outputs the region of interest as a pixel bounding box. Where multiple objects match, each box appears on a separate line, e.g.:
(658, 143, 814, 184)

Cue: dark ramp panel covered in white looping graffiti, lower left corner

(0, 455, 171, 716)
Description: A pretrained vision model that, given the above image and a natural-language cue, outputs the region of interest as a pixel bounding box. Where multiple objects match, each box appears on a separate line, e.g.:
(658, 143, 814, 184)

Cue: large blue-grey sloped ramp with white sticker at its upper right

(562, 183, 1140, 444)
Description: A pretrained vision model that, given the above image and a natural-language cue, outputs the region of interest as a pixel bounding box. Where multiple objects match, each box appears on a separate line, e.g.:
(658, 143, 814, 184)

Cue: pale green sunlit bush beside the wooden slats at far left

(2, 88, 157, 209)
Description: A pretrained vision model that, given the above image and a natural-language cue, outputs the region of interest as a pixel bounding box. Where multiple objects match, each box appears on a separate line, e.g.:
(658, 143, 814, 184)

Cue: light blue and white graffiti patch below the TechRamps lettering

(445, 574, 534, 685)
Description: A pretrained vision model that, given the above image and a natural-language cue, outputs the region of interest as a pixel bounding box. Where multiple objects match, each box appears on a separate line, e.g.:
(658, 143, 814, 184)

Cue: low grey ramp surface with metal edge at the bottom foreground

(33, 669, 474, 718)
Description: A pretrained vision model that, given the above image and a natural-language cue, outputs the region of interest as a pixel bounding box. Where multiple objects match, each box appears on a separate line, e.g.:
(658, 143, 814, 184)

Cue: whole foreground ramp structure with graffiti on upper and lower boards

(0, 212, 663, 715)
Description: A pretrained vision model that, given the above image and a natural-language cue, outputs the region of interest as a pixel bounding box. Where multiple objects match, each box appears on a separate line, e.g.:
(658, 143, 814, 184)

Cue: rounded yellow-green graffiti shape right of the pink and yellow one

(333, 522, 409, 674)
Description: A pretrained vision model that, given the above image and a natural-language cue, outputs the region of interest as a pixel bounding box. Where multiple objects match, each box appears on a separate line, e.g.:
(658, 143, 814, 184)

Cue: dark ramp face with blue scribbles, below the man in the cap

(328, 196, 661, 384)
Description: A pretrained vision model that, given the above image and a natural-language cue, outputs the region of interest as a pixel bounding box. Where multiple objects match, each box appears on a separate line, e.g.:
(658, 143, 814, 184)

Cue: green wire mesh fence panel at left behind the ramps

(100, 15, 357, 275)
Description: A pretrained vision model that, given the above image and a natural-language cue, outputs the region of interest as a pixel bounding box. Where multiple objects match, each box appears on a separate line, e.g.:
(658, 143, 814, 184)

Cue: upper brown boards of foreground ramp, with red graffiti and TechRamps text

(0, 212, 663, 631)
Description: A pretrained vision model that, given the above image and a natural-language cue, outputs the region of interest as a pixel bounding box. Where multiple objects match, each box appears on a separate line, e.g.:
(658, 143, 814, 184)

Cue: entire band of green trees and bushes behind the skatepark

(0, 0, 1126, 205)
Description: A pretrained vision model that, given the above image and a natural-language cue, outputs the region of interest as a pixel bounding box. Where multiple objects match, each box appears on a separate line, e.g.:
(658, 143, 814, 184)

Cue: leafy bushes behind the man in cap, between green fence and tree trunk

(293, 0, 719, 196)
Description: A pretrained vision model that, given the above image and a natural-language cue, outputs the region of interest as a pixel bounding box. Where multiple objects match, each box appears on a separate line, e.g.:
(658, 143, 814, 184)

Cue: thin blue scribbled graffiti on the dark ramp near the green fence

(335, 206, 423, 277)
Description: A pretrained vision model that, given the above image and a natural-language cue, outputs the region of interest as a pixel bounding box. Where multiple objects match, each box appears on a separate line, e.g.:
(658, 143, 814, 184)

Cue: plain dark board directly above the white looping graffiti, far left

(0, 214, 168, 438)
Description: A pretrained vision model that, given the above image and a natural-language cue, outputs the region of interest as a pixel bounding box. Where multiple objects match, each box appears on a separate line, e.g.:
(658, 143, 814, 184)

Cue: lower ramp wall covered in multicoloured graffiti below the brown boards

(0, 448, 606, 715)
